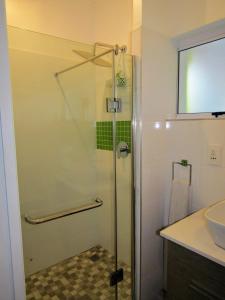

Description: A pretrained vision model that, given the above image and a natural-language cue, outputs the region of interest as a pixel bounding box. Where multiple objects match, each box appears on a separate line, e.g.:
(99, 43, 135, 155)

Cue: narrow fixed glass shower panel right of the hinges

(115, 53, 133, 300)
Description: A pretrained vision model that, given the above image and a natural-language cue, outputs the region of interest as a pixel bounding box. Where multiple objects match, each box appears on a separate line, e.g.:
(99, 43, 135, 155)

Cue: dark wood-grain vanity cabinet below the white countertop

(166, 241, 225, 300)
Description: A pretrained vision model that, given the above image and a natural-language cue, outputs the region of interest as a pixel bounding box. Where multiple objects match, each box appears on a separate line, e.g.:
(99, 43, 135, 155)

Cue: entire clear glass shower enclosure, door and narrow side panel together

(8, 27, 133, 300)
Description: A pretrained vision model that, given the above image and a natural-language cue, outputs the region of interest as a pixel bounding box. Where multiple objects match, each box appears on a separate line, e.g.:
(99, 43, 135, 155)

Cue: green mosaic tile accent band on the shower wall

(96, 121, 131, 152)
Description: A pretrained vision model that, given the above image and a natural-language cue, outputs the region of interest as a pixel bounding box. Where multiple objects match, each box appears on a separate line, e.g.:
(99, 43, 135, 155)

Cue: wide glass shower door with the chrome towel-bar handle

(9, 27, 116, 299)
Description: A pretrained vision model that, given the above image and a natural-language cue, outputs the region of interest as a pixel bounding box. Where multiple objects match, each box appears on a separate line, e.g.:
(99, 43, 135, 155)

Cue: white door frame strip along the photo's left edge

(0, 1, 25, 300)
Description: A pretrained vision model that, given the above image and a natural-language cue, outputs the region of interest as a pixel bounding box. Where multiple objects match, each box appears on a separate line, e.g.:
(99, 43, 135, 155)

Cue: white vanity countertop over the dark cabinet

(160, 209, 225, 266)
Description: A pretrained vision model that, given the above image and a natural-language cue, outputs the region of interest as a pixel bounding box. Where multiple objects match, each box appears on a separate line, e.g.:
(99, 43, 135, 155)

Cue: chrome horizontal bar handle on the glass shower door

(24, 198, 103, 224)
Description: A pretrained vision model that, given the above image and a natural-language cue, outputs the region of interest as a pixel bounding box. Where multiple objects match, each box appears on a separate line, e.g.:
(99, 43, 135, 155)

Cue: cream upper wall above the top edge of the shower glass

(6, 0, 94, 43)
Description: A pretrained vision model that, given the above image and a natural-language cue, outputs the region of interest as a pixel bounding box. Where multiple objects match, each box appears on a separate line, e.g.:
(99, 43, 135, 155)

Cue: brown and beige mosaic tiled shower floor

(26, 246, 131, 300)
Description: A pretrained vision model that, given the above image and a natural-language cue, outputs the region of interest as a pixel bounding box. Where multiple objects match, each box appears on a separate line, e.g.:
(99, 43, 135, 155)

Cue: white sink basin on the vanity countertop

(205, 200, 225, 249)
